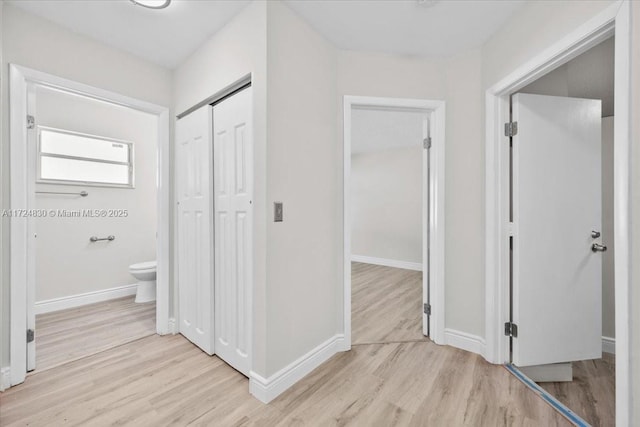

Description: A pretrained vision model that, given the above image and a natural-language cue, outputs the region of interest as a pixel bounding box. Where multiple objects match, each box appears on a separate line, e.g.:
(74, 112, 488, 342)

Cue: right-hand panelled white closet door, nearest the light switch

(213, 88, 253, 376)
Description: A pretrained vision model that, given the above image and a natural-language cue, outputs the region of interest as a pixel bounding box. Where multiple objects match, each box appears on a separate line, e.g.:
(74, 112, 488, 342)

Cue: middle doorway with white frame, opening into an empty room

(344, 96, 444, 348)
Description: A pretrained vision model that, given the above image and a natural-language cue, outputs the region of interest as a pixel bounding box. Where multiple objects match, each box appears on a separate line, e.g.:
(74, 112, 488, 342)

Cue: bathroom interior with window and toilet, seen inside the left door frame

(28, 84, 158, 370)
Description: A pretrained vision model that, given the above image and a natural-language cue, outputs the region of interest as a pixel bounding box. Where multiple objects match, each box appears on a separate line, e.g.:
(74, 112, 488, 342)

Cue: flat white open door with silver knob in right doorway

(512, 94, 603, 366)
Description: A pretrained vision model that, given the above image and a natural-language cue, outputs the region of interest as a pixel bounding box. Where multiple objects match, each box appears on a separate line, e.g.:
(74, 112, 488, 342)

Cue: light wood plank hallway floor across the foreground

(0, 266, 569, 427)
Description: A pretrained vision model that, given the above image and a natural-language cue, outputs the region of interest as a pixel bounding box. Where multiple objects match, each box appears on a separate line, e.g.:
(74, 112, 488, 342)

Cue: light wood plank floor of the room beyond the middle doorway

(351, 262, 427, 345)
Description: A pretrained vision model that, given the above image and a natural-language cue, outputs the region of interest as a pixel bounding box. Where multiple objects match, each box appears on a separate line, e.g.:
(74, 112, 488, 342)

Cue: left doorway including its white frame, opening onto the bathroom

(10, 65, 170, 385)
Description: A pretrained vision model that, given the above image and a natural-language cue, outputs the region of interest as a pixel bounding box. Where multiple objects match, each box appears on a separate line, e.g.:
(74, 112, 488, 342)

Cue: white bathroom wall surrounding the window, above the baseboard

(35, 87, 158, 302)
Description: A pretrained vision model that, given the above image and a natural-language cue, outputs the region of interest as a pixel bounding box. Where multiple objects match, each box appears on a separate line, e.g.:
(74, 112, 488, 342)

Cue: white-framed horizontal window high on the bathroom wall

(38, 126, 134, 188)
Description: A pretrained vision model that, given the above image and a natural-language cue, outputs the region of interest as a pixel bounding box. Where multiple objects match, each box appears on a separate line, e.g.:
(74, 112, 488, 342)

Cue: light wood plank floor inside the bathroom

(35, 295, 156, 372)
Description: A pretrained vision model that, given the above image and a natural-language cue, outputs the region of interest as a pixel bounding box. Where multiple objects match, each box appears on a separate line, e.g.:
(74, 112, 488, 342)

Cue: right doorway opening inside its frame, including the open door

(510, 37, 615, 425)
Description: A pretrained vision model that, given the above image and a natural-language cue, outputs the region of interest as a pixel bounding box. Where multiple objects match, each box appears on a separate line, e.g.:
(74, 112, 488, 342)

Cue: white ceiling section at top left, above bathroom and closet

(6, 0, 250, 69)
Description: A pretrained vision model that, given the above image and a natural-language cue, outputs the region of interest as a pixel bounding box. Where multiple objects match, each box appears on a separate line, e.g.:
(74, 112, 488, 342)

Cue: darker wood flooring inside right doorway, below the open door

(540, 353, 616, 427)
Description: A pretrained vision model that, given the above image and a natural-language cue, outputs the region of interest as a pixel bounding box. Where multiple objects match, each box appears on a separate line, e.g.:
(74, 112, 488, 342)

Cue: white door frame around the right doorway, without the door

(485, 1, 631, 425)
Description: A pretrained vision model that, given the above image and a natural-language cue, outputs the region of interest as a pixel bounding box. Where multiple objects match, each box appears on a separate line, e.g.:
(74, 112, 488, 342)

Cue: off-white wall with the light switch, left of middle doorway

(266, 2, 343, 375)
